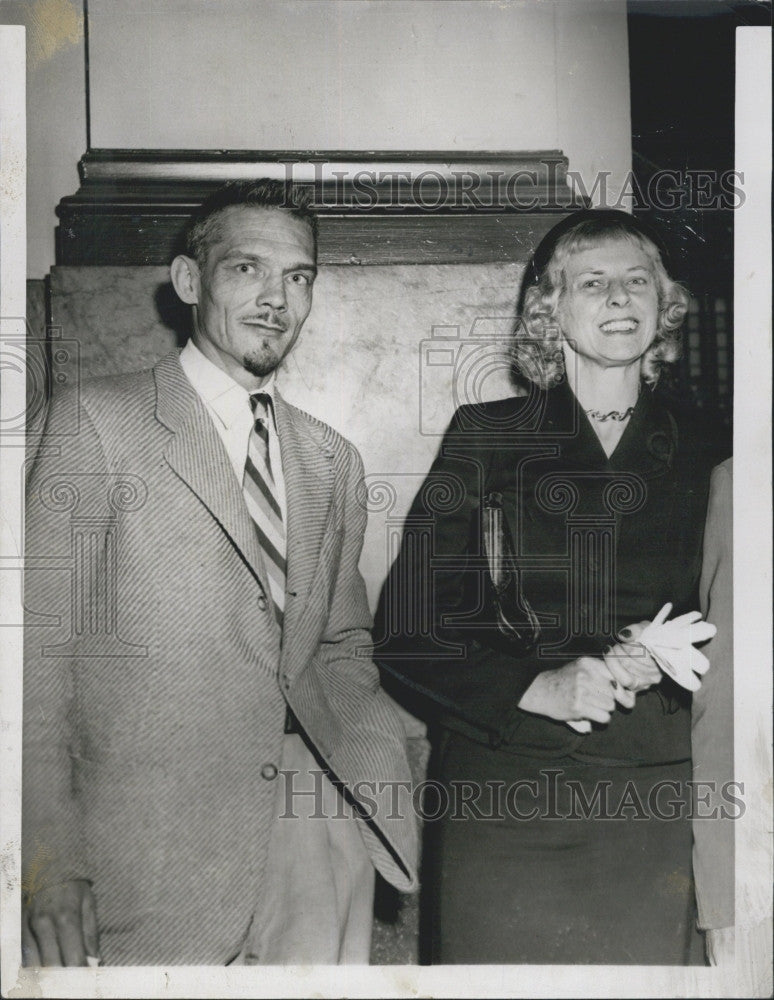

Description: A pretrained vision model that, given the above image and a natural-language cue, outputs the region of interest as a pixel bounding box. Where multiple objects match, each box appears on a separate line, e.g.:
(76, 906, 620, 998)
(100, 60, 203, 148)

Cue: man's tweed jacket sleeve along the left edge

(22, 393, 107, 896)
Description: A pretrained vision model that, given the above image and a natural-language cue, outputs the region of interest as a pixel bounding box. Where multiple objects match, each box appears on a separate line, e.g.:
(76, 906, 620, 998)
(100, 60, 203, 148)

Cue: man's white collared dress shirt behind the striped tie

(180, 340, 287, 521)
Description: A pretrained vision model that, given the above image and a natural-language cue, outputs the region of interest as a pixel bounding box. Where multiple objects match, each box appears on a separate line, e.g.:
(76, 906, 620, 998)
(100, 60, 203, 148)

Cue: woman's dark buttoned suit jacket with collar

(374, 384, 711, 763)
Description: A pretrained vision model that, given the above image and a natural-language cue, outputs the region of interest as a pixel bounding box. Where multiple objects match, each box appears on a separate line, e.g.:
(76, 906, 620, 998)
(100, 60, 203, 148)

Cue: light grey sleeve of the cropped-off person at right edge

(691, 462, 734, 930)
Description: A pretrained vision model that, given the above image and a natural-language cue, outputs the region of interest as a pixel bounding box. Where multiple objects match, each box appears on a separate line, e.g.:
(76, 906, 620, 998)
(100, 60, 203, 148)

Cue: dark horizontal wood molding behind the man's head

(56, 149, 585, 265)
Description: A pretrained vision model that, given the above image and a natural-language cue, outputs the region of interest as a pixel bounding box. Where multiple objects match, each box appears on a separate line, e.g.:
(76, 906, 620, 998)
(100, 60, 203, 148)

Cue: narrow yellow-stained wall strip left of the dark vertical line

(0, 0, 86, 278)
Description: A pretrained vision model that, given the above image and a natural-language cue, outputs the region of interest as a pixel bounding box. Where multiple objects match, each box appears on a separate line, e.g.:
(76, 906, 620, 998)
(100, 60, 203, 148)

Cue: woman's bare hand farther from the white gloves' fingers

(519, 656, 632, 724)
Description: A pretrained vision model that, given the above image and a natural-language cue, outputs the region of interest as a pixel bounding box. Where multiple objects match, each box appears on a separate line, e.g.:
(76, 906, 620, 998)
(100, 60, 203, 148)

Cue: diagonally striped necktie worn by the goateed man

(242, 392, 287, 626)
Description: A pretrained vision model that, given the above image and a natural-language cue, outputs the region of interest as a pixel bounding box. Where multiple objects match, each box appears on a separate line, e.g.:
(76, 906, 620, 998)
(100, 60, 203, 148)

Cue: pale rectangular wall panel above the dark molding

(90, 0, 557, 150)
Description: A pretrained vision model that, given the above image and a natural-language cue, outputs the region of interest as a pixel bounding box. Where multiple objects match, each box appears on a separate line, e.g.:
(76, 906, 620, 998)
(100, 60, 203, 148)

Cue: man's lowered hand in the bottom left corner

(22, 879, 99, 966)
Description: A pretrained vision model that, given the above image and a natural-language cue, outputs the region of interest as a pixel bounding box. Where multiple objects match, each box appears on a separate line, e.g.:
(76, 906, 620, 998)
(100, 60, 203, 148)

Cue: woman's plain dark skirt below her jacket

(423, 733, 703, 965)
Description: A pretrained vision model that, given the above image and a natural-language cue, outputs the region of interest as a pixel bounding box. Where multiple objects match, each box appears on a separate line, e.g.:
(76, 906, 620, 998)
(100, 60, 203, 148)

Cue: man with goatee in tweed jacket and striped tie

(23, 181, 416, 965)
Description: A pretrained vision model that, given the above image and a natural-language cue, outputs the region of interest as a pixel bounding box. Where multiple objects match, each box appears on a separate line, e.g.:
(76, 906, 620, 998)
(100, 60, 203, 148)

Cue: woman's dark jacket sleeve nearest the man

(374, 410, 543, 744)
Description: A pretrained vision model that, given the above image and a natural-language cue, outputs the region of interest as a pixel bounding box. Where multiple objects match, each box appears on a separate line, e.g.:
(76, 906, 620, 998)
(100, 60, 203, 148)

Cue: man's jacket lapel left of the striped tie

(154, 354, 269, 594)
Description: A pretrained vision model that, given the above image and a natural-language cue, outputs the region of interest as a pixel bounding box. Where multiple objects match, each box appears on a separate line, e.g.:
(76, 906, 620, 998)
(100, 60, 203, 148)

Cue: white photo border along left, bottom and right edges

(0, 13, 772, 998)
